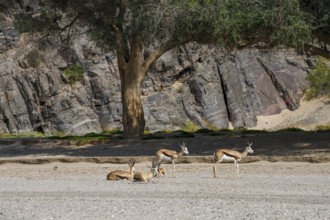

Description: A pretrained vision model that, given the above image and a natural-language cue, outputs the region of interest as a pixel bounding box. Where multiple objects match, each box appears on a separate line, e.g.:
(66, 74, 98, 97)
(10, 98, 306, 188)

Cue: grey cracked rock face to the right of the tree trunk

(143, 45, 309, 130)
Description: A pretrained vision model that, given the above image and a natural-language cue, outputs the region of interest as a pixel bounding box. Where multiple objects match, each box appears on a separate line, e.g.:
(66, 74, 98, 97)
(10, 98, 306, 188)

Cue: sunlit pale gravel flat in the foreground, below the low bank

(0, 162, 330, 220)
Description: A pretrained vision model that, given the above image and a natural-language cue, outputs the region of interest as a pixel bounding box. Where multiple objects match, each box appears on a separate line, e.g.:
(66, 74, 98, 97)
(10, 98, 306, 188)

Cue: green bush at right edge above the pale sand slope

(305, 57, 330, 100)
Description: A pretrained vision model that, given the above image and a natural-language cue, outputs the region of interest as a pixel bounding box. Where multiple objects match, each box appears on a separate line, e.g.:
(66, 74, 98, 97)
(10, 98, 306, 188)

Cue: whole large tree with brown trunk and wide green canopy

(6, 0, 330, 139)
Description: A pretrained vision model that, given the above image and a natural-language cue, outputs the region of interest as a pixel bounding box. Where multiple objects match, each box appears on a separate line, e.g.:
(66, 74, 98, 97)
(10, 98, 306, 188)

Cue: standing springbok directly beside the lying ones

(156, 143, 189, 177)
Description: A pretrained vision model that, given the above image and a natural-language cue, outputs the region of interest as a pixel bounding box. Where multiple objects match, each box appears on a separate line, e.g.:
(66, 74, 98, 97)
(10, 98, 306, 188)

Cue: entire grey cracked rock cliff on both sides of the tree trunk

(0, 12, 309, 135)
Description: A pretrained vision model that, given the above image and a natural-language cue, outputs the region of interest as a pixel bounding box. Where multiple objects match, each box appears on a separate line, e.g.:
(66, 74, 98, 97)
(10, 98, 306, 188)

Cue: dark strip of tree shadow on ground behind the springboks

(0, 132, 330, 157)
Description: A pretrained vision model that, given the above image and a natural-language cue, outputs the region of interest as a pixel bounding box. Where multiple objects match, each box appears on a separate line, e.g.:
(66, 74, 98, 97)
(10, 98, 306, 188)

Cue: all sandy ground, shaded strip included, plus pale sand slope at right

(0, 97, 330, 220)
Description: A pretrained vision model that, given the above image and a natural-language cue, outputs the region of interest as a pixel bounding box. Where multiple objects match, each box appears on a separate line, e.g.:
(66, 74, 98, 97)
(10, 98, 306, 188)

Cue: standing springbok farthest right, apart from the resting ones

(213, 143, 253, 178)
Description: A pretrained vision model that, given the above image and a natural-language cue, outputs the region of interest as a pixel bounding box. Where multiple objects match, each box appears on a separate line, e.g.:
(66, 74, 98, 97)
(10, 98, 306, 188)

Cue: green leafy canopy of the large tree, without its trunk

(12, 0, 314, 49)
